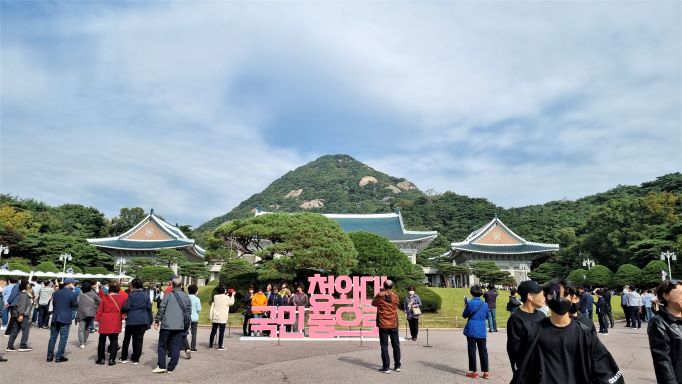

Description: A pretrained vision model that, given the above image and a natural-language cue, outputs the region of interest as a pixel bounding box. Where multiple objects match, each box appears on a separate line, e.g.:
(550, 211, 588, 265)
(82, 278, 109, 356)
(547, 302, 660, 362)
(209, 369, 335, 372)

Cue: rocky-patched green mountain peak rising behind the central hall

(198, 155, 424, 231)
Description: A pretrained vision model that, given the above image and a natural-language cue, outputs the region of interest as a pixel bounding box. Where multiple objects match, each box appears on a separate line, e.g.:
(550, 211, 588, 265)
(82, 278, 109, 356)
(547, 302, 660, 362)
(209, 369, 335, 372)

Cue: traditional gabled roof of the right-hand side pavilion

(451, 216, 559, 255)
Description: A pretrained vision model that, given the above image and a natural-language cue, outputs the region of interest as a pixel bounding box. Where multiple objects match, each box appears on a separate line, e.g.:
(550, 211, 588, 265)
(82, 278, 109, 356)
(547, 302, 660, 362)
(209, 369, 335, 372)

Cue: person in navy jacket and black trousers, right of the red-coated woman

(119, 278, 154, 365)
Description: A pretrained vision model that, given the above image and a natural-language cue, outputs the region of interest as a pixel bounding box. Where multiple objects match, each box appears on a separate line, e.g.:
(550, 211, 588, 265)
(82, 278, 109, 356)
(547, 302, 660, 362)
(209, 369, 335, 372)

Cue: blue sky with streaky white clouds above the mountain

(0, 1, 682, 226)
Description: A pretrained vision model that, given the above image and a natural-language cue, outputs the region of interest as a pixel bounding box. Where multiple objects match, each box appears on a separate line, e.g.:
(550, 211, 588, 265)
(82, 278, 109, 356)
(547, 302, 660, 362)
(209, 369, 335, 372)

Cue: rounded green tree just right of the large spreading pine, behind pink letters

(348, 232, 412, 279)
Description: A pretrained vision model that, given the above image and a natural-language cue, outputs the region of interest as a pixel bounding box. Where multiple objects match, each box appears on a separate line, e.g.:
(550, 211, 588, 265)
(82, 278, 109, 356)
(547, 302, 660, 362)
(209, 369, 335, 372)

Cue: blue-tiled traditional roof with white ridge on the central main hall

(324, 211, 438, 242)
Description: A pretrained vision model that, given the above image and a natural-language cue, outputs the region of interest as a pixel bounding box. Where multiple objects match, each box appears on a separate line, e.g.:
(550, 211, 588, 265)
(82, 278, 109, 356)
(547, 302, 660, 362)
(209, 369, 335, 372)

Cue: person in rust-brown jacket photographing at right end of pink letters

(372, 280, 401, 373)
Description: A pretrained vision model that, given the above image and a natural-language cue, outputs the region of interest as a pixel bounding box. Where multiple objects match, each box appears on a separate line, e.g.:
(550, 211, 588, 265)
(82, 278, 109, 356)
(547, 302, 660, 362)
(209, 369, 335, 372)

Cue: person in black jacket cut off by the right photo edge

(647, 280, 682, 384)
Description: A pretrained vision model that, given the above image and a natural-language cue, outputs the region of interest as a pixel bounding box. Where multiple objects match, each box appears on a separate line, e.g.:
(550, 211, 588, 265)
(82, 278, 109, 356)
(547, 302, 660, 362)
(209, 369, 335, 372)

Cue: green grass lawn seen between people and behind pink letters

(191, 282, 624, 329)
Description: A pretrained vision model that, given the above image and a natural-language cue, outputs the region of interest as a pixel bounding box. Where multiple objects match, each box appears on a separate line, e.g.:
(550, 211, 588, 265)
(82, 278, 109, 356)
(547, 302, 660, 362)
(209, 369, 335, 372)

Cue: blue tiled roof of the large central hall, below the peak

(330, 215, 435, 241)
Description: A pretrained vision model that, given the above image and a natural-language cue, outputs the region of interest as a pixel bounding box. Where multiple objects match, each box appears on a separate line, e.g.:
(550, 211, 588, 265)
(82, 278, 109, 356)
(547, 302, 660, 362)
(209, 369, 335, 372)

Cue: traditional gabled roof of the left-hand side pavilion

(88, 209, 205, 257)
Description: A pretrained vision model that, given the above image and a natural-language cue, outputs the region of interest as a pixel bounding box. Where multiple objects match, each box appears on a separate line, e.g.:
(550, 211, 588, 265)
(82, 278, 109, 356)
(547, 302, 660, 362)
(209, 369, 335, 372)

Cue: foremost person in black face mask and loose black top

(517, 281, 625, 384)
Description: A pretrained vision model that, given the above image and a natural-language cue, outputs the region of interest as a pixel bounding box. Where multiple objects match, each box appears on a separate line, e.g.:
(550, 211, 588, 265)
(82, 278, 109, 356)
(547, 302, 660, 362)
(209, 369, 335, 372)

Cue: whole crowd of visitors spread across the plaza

(0, 276, 682, 384)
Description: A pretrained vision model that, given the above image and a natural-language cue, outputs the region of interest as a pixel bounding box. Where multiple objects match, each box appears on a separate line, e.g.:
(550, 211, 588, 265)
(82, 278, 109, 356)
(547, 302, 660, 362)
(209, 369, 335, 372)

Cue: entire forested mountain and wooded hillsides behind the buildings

(0, 155, 682, 277)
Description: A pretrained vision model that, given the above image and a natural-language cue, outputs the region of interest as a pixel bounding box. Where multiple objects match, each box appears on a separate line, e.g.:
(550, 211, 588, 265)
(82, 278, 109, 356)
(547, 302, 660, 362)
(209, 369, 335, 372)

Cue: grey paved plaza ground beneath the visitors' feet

(0, 323, 656, 384)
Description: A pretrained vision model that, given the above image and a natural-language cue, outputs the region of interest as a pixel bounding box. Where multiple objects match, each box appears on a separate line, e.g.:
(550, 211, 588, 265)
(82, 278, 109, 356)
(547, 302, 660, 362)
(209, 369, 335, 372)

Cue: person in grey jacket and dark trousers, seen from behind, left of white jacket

(152, 279, 192, 373)
